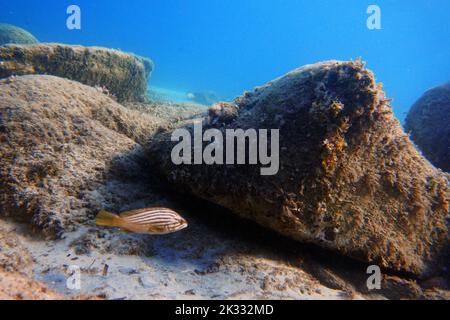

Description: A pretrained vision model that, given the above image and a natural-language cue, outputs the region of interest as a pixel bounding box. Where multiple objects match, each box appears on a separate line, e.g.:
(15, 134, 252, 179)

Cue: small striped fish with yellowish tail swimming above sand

(95, 208, 188, 235)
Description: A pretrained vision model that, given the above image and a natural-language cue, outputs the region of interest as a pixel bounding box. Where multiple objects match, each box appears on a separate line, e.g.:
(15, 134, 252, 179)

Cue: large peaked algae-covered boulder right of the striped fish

(147, 61, 449, 275)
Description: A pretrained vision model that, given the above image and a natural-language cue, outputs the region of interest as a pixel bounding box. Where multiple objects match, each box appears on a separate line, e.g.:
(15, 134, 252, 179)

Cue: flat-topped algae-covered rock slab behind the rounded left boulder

(0, 44, 153, 102)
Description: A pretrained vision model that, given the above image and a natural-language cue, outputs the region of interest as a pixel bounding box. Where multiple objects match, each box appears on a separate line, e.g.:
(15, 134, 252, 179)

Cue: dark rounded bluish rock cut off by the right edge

(405, 82, 450, 172)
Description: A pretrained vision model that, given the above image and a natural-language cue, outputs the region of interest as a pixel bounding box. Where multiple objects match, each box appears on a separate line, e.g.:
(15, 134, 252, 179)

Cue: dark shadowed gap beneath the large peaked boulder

(159, 187, 449, 299)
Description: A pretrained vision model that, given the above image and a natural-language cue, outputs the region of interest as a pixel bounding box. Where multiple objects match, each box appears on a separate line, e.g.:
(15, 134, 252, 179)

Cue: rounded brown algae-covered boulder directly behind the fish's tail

(0, 75, 176, 237)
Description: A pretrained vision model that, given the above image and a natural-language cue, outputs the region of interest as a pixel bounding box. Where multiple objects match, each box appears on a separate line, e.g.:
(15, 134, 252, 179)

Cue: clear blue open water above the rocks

(0, 0, 450, 119)
